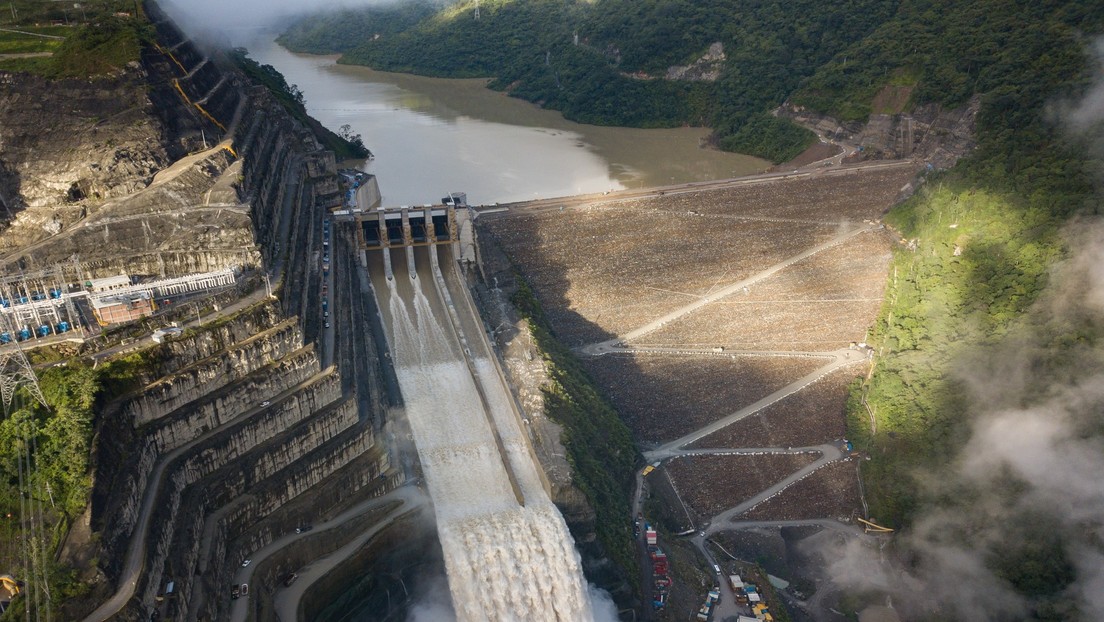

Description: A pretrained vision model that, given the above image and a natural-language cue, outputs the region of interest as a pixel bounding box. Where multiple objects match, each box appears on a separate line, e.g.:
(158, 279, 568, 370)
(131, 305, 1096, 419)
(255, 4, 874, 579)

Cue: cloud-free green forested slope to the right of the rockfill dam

(808, 0, 1104, 620)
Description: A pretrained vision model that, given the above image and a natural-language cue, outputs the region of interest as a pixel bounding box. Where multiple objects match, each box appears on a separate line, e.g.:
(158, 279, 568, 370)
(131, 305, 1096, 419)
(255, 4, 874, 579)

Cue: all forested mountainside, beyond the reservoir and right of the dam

(283, 0, 1104, 621)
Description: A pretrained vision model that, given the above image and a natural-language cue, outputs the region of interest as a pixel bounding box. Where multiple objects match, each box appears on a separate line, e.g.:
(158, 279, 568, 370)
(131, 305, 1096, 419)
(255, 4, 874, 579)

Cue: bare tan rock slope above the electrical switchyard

(0, 9, 261, 277)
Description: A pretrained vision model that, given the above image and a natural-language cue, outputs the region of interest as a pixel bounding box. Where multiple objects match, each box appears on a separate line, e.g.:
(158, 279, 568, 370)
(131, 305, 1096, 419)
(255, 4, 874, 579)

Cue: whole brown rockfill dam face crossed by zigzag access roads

(478, 162, 916, 620)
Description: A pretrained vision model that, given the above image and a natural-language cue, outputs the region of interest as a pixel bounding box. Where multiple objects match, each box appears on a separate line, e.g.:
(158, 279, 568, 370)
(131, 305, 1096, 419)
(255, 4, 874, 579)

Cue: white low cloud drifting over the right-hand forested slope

(822, 39, 1104, 622)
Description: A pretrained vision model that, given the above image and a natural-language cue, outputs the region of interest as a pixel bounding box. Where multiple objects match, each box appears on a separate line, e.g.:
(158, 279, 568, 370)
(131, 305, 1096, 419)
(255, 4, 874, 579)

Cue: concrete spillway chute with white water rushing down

(369, 246, 593, 622)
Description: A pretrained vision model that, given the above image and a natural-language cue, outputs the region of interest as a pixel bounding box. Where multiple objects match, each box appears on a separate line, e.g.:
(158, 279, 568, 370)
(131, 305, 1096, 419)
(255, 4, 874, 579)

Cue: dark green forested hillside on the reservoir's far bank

(280, 0, 896, 161)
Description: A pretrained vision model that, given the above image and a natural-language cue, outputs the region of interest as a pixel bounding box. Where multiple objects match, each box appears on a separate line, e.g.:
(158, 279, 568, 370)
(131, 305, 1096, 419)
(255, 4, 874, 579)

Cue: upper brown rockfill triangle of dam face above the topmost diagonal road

(487, 207, 837, 346)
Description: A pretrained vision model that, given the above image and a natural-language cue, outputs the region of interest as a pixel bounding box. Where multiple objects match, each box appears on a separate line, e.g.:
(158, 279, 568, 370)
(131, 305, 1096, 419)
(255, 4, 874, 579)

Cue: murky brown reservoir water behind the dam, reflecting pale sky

(240, 34, 769, 205)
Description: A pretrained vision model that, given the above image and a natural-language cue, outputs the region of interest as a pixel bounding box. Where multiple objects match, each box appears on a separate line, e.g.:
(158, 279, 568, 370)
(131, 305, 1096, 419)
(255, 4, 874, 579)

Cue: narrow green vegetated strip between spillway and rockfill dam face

(513, 274, 638, 576)
